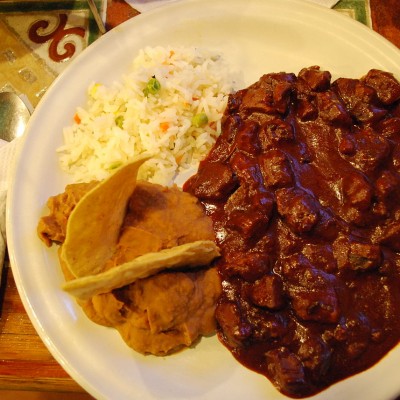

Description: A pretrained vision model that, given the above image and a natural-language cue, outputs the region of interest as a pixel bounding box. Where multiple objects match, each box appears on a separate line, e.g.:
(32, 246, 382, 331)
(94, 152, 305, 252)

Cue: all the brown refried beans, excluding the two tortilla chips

(38, 182, 221, 356)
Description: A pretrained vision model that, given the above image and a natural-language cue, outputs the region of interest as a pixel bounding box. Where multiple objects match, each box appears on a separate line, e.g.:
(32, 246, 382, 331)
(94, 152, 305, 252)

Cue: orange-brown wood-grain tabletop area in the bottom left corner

(0, 268, 92, 400)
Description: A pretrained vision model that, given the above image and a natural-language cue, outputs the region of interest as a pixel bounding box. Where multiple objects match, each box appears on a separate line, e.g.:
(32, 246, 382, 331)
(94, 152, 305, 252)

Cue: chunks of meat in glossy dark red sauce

(184, 67, 400, 398)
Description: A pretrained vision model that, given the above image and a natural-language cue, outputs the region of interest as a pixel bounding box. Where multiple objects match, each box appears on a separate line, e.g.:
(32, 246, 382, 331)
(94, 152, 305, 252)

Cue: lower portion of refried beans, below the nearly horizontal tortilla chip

(81, 268, 221, 356)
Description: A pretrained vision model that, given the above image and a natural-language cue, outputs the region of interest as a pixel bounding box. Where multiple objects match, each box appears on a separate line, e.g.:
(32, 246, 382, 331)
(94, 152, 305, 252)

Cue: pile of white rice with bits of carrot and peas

(57, 47, 235, 185)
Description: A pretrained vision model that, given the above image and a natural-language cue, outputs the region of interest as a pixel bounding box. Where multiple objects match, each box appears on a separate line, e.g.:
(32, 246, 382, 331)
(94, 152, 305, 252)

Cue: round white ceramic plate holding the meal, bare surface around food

(7, 0, 400, 400)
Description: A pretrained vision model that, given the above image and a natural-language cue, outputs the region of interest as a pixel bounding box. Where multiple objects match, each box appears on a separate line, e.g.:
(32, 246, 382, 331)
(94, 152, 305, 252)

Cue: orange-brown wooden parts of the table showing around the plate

(0, 0, 400, 400)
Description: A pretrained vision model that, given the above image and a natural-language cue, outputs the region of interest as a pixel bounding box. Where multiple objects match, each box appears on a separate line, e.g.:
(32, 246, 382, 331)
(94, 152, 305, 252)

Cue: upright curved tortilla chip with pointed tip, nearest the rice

(61, 155, 150, 277)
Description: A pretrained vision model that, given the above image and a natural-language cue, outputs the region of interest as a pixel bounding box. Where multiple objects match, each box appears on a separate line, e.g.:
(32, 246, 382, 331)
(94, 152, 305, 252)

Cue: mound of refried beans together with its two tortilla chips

(38, 156, 221, 355)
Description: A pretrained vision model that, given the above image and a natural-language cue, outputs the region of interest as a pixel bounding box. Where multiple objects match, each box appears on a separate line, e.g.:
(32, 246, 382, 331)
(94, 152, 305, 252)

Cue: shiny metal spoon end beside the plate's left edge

(0, 92, 31, 142)
